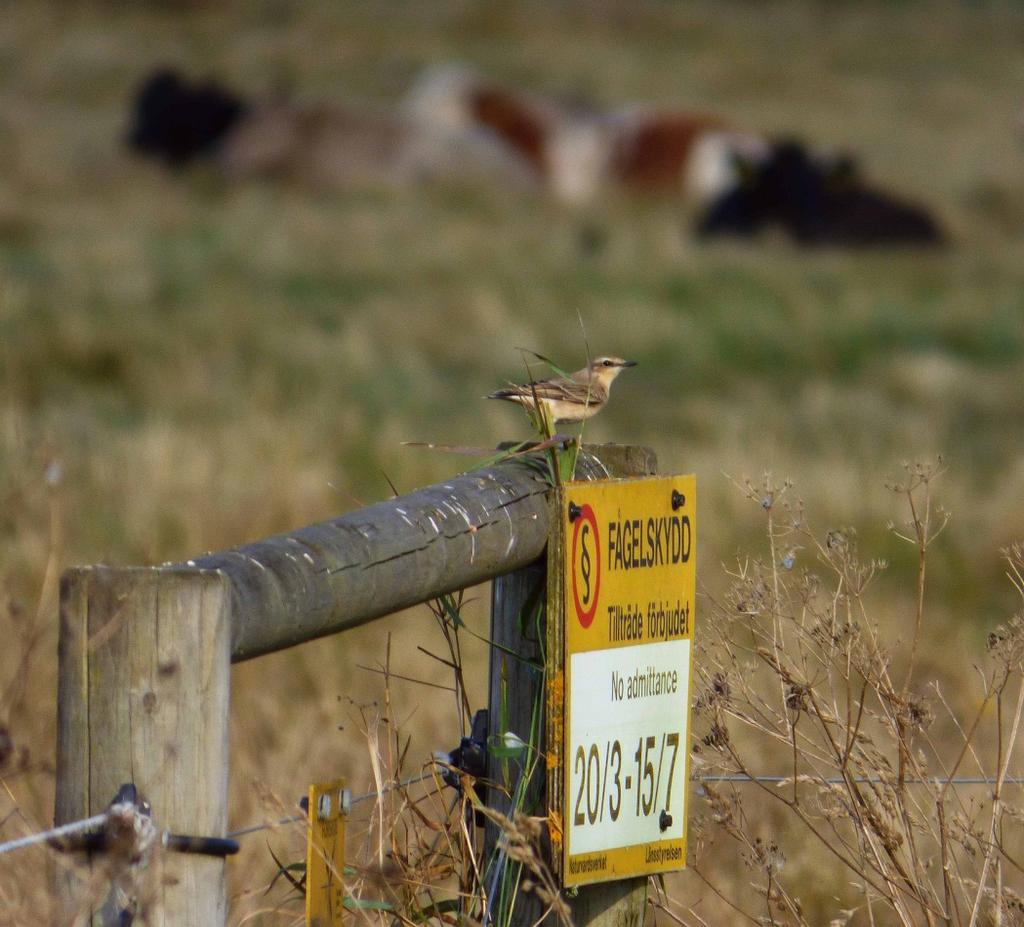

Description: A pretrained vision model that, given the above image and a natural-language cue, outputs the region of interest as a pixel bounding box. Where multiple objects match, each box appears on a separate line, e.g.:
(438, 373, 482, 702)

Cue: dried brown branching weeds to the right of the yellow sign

(682, 465, 1024, 925)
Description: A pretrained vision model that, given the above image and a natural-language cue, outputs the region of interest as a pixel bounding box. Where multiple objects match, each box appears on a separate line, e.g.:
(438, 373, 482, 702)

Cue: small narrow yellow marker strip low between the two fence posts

(306, 779, 350, 927)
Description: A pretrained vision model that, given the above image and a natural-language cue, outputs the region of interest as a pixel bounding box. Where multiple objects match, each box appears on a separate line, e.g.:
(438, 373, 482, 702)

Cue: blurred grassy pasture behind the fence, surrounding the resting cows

(0, 0, 1024, 923)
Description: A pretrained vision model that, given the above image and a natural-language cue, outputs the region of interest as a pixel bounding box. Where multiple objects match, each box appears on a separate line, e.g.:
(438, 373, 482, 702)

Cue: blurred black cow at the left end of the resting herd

(128, 69, 248, 167)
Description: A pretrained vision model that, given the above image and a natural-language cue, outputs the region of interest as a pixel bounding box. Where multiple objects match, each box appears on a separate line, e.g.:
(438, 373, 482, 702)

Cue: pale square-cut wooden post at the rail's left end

(55, 567, 230, 927)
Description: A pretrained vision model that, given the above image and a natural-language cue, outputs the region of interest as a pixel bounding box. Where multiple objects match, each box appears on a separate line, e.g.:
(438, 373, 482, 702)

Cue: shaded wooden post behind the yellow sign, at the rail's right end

(486, 445, 657, 927)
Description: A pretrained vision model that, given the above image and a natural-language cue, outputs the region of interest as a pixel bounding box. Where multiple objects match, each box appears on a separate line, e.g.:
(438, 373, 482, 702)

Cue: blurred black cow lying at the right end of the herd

(696, 141, 943, 247)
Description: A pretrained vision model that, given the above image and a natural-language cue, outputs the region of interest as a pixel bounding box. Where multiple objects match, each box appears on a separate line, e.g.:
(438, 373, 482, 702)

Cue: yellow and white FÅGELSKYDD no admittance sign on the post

(561, 476, 696, 886)
